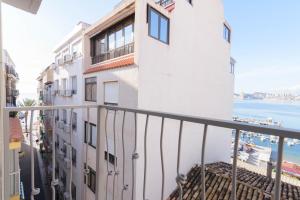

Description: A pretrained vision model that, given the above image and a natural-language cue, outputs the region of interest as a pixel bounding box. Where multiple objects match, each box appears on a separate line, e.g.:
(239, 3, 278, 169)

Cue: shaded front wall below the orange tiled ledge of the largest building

(83, 65, 138, 199)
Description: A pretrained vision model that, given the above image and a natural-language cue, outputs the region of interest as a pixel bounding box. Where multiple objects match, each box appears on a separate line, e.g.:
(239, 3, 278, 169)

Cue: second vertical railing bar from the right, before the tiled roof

(231, 130, 240, 200)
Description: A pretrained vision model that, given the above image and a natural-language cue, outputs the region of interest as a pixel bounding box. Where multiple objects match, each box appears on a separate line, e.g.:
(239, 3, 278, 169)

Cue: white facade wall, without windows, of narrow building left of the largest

(54, 29, 84, 199)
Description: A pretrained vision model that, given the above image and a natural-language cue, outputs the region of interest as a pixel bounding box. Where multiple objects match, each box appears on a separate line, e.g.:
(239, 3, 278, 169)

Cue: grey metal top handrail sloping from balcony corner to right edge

(100, 105, 300, 139)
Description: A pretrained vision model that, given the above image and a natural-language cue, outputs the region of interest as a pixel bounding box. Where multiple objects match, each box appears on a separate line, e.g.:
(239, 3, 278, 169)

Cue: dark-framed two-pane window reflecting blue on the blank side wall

(148, 6, 170, 44)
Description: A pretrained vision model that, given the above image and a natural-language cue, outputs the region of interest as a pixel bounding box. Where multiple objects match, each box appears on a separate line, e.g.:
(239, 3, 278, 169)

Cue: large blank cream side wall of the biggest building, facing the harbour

(135, 0, 233, 199)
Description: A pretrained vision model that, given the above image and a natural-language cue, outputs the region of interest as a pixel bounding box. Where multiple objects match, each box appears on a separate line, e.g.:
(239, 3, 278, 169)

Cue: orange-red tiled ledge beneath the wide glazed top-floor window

(84, 54, 134, 74)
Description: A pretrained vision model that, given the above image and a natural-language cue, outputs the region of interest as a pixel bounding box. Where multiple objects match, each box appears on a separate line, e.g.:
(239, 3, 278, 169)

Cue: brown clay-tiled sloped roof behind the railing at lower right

(168, 162, 300, 200)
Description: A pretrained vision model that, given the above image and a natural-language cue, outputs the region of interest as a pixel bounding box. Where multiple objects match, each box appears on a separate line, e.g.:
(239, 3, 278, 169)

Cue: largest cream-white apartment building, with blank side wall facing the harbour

(83, 0, 234, 199)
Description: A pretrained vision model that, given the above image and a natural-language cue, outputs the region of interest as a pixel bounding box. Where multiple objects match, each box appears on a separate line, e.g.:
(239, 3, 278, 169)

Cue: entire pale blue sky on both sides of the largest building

(2, 0, 300, 98)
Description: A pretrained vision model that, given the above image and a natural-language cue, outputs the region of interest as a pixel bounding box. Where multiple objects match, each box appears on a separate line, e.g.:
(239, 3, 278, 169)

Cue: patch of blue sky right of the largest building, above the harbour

(224, 0, 300, 92)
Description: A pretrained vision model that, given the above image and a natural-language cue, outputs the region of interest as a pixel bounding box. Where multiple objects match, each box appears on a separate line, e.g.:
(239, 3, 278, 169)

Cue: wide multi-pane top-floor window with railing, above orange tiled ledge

(91, 15, 134, 64)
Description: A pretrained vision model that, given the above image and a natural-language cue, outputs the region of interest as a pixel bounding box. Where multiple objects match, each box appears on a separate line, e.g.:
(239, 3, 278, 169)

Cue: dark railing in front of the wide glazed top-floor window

(92, 43, 134, 64)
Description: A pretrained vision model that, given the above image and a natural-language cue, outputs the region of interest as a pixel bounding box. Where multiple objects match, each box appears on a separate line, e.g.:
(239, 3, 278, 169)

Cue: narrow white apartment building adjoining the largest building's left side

(52, 22, 89, 200)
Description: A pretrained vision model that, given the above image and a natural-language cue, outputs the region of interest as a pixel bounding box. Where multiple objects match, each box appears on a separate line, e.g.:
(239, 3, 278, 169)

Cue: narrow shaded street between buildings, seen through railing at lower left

(20, 143, 45, 200)
